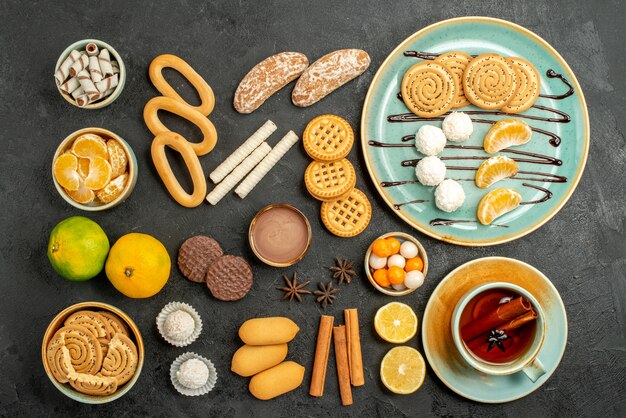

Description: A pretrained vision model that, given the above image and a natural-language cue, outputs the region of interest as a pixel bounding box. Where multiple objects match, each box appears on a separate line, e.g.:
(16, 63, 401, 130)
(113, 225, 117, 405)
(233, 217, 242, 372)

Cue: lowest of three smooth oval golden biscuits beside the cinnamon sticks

(249, 361, 304, 401)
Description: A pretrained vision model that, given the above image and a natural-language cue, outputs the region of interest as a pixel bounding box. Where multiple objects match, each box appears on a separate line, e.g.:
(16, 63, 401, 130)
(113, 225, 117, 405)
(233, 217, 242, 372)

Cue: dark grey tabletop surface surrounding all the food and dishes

(0, 0, 626, 417)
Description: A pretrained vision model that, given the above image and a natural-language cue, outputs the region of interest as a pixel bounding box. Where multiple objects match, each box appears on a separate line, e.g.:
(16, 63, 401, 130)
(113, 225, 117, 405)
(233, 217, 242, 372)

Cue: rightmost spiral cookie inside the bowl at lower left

(99, 334, 139, 386)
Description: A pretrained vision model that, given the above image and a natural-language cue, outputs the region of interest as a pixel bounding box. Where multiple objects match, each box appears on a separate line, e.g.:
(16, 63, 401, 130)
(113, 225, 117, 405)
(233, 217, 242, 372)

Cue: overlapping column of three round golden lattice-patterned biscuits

(302, 115, 372, 237)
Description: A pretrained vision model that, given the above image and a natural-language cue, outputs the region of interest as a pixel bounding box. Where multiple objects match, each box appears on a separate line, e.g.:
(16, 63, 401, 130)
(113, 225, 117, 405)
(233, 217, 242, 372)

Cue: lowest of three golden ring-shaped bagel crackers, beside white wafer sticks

(151, 132, 206, 208)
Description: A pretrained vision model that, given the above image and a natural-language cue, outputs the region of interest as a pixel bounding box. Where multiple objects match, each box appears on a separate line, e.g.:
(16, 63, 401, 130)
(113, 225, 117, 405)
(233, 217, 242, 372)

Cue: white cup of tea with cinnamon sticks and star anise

(451, 282, 546, 382)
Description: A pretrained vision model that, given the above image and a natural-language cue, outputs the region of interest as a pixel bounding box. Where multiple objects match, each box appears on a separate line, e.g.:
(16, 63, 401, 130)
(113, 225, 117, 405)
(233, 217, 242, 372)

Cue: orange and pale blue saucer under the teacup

(421, 257, 567, 403)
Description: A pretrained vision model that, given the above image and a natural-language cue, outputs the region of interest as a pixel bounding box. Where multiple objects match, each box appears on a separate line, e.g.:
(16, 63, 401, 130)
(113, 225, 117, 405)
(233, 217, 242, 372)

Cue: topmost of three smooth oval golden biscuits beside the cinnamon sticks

(239, 316, 300, 345)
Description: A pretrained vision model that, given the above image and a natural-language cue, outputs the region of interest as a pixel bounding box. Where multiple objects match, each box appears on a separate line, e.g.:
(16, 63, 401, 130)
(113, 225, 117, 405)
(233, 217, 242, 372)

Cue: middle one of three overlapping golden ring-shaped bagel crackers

(143, 96, 217, 156)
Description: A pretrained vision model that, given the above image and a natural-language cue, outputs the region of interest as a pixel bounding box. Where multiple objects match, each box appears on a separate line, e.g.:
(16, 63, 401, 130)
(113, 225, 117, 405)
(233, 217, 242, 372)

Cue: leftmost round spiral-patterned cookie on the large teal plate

(402, 61, 457, 118)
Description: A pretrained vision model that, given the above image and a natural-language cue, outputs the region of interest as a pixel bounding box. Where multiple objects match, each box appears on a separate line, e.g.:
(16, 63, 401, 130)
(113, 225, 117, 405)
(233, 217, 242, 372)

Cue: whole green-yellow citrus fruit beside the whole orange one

(48, 216, 109, 282)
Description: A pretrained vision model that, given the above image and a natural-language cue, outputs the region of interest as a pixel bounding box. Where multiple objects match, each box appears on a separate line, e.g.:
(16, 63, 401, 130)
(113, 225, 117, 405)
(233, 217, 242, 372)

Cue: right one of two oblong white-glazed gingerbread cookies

(291, 49, 370, 107)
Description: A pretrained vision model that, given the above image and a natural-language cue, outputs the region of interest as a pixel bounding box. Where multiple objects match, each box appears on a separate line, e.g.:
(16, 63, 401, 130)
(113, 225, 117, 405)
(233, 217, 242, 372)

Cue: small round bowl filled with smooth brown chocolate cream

(248, 204, 312, 267)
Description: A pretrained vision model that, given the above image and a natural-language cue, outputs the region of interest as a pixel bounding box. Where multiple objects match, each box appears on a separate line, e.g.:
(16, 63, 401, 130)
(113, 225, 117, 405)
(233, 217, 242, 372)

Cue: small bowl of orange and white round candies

(364, 232, 428, 296)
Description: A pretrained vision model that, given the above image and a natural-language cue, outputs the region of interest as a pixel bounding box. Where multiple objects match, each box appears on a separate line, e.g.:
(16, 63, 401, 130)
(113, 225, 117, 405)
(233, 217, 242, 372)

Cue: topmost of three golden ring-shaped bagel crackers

(148, 54, 215, 116)
